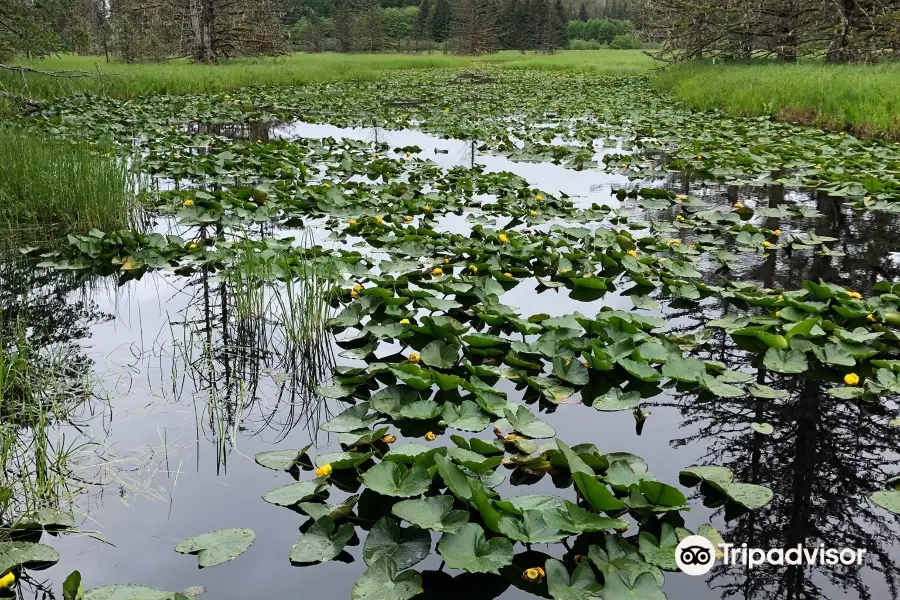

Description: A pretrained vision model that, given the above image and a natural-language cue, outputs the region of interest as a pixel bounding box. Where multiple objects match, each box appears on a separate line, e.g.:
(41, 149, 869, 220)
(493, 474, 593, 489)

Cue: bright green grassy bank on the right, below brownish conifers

(655, 63, 900, 140)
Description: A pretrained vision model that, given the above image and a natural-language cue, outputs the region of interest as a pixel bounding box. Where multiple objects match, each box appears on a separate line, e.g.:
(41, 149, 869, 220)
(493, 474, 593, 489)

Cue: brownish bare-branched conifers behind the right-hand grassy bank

(638, 0, 900, 63)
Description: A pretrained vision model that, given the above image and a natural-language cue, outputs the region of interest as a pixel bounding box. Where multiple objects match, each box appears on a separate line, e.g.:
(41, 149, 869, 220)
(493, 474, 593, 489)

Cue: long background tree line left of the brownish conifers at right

(0, 0, 641, 62)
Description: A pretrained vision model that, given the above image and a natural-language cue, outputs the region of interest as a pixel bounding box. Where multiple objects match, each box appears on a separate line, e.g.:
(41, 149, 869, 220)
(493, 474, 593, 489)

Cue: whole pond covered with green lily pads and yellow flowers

(0, 70, 900, 600)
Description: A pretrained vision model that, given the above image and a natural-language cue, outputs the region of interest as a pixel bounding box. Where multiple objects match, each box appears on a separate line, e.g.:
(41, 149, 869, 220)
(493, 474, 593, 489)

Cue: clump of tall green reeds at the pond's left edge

(0, 128, 135, 250)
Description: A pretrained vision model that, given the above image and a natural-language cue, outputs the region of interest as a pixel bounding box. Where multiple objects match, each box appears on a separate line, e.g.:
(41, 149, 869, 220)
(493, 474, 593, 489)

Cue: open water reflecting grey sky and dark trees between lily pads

(7, 125, 900, 600)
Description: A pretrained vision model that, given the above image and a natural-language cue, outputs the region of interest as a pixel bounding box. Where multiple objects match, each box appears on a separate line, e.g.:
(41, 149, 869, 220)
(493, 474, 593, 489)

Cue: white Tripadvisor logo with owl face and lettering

(675, 535, 866, 576)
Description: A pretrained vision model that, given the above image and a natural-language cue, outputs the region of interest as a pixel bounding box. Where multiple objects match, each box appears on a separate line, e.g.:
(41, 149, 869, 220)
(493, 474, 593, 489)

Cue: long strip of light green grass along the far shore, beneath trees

(0, 50, 653, 100)
